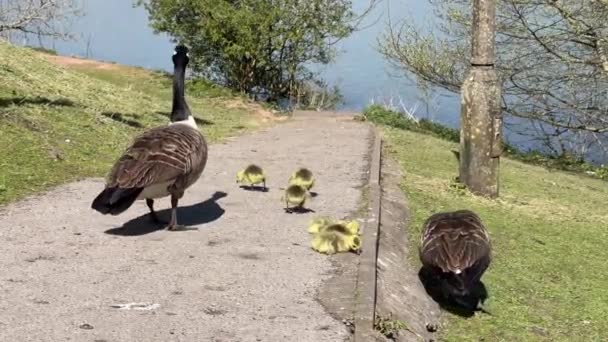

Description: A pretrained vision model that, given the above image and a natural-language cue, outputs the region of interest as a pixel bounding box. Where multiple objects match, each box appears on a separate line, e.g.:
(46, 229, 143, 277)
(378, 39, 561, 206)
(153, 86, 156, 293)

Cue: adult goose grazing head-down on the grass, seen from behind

(420, 210, 491, 305)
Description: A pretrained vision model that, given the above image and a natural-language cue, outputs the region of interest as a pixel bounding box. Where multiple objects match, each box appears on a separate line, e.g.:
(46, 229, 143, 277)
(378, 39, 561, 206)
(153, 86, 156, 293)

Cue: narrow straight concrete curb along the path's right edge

(354, 128, 382, 342)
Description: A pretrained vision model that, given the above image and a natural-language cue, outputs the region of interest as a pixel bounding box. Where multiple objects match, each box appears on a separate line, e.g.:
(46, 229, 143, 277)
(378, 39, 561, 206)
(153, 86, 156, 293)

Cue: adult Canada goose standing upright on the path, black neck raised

(91, 45, 207, 230)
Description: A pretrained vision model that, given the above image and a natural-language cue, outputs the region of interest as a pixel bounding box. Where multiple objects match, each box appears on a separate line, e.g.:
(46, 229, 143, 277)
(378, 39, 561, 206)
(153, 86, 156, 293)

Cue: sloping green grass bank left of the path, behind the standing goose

(0, 42, 270, 204)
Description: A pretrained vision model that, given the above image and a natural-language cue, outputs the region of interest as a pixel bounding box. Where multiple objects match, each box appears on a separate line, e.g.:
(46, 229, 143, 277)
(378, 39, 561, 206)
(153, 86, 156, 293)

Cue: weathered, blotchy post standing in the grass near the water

(459, 0, 502, 198)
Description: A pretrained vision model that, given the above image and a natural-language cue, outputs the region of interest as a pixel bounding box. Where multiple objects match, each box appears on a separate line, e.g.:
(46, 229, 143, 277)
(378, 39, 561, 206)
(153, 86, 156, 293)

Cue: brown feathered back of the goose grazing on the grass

(420, 210, 490, 272)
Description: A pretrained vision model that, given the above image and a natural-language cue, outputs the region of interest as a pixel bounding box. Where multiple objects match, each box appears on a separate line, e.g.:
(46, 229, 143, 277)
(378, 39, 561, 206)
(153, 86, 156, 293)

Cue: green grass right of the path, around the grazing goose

(366, 107, 608, 341)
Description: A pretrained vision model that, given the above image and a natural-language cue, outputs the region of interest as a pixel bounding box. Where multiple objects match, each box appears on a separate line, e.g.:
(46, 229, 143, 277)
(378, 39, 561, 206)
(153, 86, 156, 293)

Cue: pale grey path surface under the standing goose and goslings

(0, 116, 372, 342)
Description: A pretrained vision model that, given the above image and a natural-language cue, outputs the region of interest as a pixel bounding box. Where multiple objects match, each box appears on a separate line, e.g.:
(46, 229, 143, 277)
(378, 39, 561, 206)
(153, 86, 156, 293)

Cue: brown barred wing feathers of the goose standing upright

(108, 125, 207, 188)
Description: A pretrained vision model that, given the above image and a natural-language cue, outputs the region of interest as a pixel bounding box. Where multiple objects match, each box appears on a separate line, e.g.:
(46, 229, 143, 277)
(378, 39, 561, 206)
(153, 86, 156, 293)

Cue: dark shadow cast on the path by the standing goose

(105, 191, 228, 236)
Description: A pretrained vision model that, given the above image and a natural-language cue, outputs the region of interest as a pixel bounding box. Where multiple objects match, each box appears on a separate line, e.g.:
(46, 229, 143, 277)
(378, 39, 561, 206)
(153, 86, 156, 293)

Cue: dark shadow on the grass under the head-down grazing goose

(418, 267, 489, 318)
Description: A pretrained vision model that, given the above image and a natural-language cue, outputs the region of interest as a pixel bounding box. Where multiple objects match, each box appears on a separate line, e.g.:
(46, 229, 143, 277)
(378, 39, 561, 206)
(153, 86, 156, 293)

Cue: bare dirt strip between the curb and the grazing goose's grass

(376, 156, 440, 341)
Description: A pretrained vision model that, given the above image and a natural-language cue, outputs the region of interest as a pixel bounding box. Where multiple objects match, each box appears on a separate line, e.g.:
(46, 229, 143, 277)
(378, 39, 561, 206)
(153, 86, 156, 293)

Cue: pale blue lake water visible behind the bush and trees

(23, 0, 604, 162)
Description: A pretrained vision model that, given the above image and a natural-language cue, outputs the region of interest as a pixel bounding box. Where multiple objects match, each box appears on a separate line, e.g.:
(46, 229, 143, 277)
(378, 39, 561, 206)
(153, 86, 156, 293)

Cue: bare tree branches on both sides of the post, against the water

(379, 0, 608, 160)
